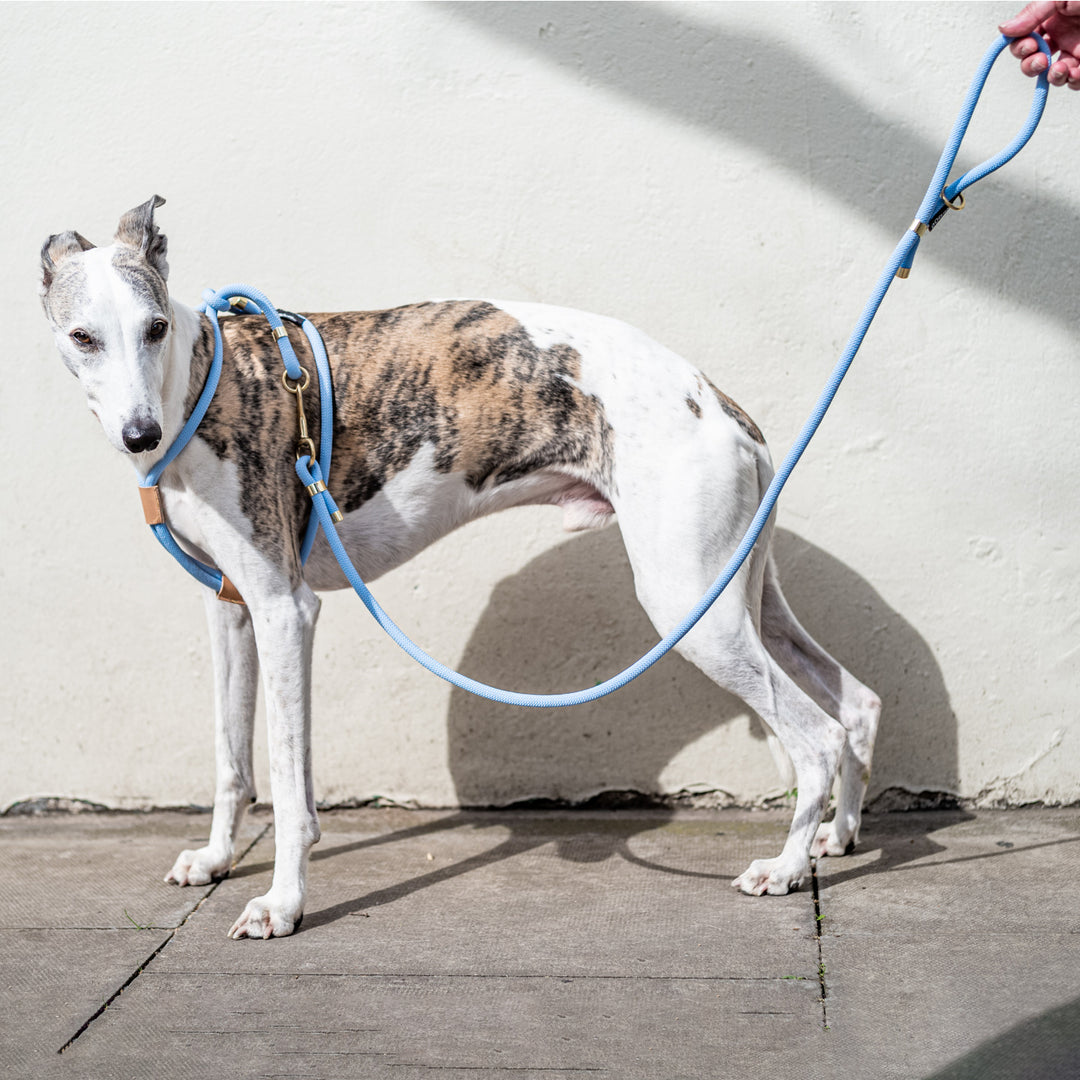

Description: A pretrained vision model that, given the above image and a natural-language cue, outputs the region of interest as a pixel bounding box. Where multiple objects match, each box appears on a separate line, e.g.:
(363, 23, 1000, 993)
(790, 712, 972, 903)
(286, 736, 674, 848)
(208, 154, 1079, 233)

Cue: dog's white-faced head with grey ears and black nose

(41, 195, 173, 454)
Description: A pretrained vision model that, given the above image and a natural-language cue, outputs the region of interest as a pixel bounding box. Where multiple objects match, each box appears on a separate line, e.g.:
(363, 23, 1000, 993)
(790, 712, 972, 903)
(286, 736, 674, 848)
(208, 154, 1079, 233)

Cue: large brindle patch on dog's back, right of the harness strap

(314, 301, 611, 512)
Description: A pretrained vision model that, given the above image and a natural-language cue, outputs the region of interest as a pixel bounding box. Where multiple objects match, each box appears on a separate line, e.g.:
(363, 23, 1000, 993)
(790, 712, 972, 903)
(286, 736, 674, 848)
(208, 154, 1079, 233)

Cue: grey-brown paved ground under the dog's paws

(0, 809, 1080, 1080)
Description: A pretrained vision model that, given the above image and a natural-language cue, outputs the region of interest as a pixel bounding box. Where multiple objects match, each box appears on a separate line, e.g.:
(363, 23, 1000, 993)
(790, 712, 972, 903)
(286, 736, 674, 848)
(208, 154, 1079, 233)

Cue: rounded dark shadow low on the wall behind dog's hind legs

(447, 528, 958, 807)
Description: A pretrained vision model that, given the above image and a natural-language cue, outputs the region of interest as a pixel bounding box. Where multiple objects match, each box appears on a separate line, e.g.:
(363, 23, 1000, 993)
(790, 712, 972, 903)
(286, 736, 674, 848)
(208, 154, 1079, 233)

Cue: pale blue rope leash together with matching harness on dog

(143, 35, 1051, 708)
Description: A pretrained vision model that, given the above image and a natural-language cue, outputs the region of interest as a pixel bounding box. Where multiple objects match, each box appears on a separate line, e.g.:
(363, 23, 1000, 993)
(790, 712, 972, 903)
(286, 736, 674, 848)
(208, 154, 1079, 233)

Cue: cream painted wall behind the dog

(0, 3, 1080, 807)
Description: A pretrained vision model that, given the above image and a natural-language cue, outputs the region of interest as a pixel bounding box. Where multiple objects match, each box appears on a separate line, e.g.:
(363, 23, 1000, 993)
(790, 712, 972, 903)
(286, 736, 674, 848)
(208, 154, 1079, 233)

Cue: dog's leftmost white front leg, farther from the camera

(165, 590, 259, 885)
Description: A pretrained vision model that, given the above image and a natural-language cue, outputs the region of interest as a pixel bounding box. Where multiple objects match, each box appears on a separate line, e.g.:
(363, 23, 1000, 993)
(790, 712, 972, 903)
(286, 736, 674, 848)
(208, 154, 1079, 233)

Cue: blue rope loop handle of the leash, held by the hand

(896, 33, 1053, 278)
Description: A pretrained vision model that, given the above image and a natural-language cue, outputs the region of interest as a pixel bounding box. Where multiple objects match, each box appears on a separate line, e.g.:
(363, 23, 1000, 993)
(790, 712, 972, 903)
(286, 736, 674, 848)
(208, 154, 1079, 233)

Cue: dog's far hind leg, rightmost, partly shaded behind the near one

(761, 556, 881, 856)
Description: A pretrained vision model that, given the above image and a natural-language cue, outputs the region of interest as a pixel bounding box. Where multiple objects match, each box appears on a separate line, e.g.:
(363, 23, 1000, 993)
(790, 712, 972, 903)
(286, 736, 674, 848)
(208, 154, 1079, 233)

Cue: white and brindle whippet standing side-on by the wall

(41, 195, 880, 939)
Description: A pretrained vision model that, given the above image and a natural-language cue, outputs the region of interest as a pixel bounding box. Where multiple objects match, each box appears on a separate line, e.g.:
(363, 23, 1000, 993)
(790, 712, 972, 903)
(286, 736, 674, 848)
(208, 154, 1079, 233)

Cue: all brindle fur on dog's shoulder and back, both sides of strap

(186, 301, 612, 557)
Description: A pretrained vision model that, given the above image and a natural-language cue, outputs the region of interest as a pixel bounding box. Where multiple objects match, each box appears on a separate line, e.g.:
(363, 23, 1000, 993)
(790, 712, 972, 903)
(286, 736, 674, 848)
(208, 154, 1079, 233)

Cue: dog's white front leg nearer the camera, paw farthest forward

(223, 584, 320, 937)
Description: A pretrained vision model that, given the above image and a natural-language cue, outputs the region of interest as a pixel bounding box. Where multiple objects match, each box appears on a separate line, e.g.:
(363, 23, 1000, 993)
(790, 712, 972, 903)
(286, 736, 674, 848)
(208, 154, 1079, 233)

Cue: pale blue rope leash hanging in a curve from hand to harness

(141, 36, 1051, 708)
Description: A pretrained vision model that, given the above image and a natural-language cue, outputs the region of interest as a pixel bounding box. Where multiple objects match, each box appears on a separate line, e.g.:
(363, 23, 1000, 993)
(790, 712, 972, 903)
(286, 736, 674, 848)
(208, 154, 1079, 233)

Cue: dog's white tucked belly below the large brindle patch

(303, 445, 615, 590)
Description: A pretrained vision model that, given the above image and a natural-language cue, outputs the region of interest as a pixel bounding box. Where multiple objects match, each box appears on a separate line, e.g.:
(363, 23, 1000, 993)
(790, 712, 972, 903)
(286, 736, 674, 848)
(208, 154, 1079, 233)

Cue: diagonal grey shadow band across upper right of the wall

(441, 0, 1080, 325)
